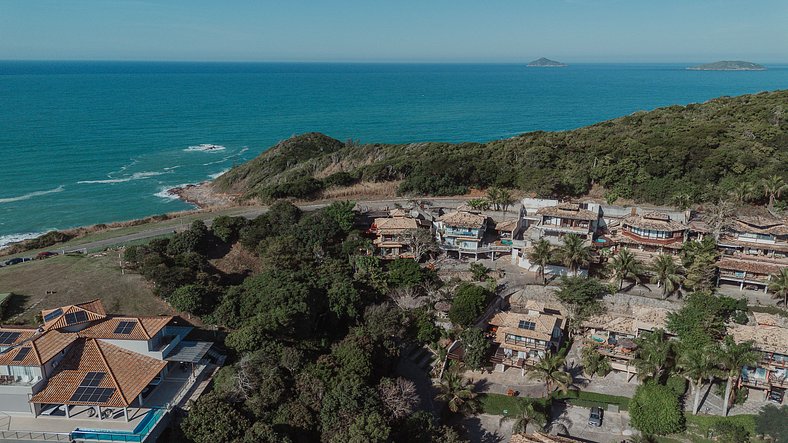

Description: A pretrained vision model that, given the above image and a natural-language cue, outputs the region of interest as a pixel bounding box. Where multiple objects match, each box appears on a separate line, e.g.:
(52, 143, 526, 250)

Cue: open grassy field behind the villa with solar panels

(0, 254, 174, 324)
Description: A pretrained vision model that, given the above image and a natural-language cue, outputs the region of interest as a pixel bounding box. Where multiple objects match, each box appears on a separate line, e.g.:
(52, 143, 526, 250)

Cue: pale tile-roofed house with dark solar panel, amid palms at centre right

(489, 300, 567, 373)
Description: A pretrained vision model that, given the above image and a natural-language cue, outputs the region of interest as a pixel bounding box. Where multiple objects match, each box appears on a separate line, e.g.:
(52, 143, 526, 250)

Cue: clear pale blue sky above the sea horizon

(0, 0, 788, 63)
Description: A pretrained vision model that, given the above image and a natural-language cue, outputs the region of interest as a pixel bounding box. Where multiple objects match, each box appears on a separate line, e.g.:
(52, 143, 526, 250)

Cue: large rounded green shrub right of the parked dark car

(629, 383, 684, 435)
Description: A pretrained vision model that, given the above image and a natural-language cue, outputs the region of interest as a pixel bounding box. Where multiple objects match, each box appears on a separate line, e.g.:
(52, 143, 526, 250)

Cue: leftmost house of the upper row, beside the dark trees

(368, 208, 432, 259)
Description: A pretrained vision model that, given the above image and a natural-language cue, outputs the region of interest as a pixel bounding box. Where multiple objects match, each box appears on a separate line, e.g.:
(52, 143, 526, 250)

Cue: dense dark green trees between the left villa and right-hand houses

(125, 202, 468, 443)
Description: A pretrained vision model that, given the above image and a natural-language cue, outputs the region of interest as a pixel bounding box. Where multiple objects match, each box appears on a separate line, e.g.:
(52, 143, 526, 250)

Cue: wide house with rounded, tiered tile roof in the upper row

(611, 208, 688, 258)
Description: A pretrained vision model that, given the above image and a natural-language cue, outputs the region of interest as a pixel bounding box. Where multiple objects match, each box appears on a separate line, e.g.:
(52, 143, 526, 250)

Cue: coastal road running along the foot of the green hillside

(57, 197, 467, 252)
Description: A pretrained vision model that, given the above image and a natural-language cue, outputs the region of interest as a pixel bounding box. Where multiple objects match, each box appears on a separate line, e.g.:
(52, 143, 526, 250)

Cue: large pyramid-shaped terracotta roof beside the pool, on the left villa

(30, 339, 167, 407)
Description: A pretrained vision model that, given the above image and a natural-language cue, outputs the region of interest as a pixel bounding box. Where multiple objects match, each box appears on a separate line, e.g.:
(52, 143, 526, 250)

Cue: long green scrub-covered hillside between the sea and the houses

(213, 90, 788, 204)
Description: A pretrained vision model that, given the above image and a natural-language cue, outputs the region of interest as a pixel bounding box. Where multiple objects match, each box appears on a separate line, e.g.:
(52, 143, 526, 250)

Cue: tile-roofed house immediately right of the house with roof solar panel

(582, 307, 670, 379)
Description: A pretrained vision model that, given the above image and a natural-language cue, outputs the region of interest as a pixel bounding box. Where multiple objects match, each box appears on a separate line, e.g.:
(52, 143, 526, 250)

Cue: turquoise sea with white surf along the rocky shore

(0, 62, 788, 243)
